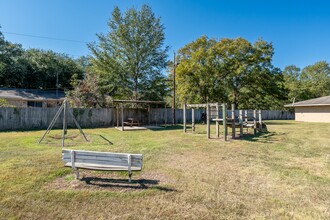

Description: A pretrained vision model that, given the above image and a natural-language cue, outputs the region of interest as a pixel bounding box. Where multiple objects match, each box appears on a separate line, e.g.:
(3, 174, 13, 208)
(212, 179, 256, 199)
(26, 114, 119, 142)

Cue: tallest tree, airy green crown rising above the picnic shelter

(89, 5, 168, 100)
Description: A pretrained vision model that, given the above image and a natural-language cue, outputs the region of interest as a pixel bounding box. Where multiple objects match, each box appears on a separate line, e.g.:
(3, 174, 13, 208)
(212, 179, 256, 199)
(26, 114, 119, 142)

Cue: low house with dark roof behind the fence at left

(0, 88, 65, 108)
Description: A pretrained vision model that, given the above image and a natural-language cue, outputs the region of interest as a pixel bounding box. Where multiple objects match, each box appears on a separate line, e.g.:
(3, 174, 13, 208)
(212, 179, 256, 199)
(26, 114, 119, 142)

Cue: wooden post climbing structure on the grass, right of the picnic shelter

(183, 103, 263, 141)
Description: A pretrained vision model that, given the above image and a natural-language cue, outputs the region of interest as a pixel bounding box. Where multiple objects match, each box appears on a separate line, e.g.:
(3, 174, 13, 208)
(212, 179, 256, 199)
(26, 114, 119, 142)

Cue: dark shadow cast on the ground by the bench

(81, 177, 177, 192)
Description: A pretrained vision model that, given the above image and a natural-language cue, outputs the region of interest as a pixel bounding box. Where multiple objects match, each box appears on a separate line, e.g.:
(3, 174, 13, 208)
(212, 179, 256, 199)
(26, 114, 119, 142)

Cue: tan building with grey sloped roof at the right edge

(285, 96, 330, 122)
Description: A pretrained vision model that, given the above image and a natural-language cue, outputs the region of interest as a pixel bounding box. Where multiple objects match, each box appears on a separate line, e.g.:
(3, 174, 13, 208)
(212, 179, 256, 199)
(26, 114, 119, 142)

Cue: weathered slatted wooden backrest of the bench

(62, 149, 142, 169)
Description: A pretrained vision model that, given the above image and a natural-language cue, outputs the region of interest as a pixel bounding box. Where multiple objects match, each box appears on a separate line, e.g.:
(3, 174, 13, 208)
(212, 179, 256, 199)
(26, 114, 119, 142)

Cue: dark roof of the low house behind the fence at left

(0, 88, 65, 101)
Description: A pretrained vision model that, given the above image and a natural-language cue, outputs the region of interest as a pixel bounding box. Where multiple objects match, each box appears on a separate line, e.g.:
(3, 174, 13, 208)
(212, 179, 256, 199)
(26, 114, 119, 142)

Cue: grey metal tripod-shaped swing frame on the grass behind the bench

(38, 99, 88, 147)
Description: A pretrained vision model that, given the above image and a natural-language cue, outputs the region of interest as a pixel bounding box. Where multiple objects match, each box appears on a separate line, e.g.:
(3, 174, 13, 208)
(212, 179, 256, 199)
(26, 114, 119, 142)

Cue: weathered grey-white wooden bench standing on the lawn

(62, 149, 143, 182)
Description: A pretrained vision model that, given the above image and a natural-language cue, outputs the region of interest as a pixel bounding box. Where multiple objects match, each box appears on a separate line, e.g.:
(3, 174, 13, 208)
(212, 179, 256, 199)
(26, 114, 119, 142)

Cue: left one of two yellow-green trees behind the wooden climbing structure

(176, 36, 223, 103)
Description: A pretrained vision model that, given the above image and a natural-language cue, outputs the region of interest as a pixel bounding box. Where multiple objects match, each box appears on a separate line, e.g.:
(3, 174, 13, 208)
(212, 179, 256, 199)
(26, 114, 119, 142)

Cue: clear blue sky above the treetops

(0, 0, 330, 69)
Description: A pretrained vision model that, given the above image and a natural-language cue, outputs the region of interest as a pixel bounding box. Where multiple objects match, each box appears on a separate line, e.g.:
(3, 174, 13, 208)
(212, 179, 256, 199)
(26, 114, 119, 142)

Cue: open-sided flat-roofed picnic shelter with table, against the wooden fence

(112, 100, 167, 131)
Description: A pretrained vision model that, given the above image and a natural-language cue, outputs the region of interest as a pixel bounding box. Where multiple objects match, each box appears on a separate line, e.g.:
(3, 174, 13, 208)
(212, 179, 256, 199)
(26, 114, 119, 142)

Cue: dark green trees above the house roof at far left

(0, 29, 83, 89)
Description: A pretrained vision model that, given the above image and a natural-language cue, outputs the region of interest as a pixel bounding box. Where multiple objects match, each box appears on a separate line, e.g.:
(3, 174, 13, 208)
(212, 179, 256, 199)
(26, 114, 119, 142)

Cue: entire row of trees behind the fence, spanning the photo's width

(0, 5, 330, 109)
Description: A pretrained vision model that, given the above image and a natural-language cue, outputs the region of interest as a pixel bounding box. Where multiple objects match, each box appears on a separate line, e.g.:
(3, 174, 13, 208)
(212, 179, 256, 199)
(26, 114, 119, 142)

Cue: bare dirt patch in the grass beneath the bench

(45, 171, 176, 192)
